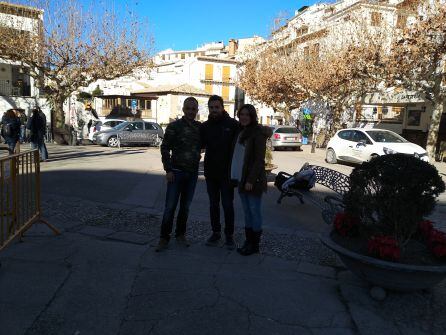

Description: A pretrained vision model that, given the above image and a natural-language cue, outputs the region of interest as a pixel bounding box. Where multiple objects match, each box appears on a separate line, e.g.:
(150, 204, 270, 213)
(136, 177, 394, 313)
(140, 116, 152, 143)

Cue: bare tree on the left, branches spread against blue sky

(0, 0, 152, 140)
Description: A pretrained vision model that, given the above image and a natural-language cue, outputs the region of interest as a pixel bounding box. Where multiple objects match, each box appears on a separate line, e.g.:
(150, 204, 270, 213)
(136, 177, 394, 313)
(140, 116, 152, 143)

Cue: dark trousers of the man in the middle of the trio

(206, 178, 234, 236)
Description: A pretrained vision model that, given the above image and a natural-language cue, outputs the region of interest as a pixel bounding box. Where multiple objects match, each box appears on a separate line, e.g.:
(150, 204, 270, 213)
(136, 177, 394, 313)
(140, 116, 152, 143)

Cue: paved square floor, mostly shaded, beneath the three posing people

(0, 146, 446, 335)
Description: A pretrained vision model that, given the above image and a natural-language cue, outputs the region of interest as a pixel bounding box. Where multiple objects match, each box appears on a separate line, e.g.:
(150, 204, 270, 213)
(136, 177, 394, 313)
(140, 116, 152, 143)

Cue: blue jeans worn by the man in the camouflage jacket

(161, 171, 198, 240)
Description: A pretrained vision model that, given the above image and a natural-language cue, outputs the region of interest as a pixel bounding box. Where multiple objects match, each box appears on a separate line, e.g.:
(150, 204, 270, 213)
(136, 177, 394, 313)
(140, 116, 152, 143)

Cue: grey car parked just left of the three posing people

(93, 120, 164, 147)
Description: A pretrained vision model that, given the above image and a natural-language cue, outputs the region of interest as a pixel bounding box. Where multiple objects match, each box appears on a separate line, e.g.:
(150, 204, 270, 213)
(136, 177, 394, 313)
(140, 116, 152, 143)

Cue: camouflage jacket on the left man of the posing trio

(161, 117, 201, 172)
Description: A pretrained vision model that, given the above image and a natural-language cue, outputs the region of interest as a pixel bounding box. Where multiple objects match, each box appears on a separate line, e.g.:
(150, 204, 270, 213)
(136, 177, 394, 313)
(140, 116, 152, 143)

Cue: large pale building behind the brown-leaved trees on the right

(269, 0, 440, 145)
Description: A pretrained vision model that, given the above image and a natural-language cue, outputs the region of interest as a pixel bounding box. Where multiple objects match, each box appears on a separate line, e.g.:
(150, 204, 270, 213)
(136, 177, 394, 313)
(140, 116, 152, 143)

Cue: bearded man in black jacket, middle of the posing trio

(201, 95, 239, 249)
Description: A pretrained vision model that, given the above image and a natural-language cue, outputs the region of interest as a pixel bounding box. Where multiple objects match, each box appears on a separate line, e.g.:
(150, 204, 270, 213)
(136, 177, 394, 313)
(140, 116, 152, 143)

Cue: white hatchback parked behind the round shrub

(325, 128, 429, 164)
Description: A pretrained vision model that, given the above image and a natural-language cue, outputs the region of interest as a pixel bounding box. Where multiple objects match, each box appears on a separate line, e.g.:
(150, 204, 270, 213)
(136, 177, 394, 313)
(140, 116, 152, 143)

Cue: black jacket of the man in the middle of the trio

(201, 112, 239, 180)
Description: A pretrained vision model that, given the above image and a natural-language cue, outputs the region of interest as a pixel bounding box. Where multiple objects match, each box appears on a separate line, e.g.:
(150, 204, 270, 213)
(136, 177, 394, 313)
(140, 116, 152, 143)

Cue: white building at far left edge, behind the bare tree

(0, 2, 51, 122)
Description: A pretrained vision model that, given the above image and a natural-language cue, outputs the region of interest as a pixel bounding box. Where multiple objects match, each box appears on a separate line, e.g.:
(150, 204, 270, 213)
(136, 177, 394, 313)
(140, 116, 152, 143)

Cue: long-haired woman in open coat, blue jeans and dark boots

(231, 104, 272, 256)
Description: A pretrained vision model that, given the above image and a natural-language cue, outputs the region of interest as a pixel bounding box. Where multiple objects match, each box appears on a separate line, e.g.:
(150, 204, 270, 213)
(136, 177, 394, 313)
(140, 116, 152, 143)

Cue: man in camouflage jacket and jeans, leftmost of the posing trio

(156, 97, 201, 251)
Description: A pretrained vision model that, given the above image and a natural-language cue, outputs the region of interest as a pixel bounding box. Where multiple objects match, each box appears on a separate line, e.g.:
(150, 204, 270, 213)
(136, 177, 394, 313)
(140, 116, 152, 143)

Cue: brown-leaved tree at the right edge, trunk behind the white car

(388, 0, 446, 158)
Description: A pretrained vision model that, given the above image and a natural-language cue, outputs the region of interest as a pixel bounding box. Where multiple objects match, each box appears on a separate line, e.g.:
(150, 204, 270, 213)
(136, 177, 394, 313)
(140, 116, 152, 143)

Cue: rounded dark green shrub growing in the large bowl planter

(344, 154, 445, 245)
